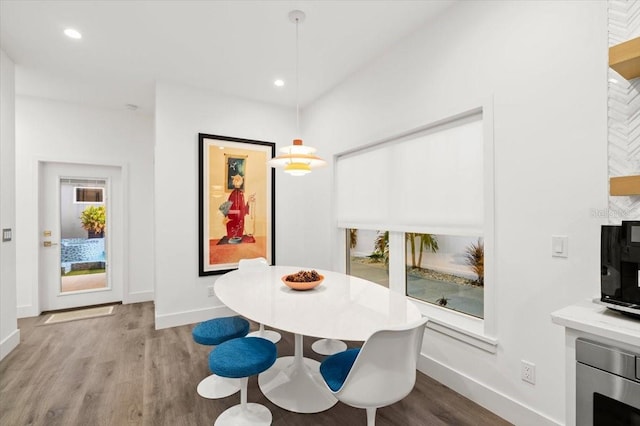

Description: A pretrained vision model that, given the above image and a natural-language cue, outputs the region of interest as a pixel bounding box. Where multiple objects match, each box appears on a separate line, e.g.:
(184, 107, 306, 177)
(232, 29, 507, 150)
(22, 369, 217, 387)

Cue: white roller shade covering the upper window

(335, 114, 484, 234)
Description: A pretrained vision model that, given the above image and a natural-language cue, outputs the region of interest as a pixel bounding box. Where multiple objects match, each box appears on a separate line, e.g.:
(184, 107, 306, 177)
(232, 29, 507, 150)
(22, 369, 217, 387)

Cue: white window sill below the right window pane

(409, 297, 498, 354)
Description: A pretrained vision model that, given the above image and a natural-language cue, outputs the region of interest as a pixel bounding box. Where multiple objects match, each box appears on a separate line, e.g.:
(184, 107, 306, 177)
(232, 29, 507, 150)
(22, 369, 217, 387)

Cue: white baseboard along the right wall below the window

(418, 354, 562, 426)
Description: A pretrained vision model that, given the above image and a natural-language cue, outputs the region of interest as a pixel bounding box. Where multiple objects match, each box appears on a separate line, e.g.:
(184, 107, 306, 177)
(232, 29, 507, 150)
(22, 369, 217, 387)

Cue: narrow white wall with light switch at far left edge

(0, 50, 20, 360)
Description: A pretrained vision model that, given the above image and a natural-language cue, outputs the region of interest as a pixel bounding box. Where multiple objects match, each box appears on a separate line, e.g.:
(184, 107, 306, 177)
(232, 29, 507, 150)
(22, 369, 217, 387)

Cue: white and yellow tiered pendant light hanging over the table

(268, 10, 327, 176)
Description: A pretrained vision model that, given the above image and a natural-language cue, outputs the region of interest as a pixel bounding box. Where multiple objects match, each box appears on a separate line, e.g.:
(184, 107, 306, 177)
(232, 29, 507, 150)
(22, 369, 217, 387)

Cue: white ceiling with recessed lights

(0, 0, 455, 113)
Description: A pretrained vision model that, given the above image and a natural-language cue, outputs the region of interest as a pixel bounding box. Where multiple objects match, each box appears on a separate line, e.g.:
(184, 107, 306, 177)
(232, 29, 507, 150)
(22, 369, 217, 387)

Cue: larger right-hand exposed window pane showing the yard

(405, 233, 484, 318)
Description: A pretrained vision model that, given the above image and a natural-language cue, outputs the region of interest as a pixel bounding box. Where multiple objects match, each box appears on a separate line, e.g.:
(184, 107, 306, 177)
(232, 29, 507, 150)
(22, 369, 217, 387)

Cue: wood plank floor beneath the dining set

(0, 302, 508, 426)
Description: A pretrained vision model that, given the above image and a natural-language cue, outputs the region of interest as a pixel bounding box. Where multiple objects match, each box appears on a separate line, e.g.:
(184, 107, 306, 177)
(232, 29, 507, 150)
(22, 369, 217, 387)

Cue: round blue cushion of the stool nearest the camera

(209, 337, 278, 379)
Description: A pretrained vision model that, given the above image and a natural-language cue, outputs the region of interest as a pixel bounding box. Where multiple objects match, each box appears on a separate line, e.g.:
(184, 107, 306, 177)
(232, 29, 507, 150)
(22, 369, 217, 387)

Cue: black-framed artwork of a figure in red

(198, 133, 276, 276)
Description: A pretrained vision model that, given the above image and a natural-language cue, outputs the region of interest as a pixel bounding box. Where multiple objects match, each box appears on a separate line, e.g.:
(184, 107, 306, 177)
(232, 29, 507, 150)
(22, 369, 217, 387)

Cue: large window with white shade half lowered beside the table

(334, 103, 497, 352)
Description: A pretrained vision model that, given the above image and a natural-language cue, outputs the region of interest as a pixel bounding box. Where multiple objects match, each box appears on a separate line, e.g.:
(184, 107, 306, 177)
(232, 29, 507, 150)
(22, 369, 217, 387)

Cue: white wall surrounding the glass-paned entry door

(16, 96, 154, 317)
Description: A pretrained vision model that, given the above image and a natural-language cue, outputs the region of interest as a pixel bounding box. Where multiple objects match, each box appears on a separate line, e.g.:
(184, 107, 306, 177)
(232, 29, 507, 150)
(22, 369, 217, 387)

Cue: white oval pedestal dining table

(214, 266, 421, 413)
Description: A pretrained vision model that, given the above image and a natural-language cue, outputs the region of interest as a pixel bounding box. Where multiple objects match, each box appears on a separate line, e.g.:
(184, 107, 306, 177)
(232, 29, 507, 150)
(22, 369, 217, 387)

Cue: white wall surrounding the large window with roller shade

(302, 1, 607, 425)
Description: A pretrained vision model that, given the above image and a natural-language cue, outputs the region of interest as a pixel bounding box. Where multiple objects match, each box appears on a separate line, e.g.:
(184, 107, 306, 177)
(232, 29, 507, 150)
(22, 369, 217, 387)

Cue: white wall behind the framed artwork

(155, 83, 310, 328)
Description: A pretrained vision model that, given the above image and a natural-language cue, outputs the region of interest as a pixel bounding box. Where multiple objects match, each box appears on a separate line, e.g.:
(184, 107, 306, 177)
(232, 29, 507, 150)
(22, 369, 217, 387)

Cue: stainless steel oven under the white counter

(576, 338, 640, 426)
